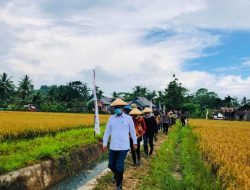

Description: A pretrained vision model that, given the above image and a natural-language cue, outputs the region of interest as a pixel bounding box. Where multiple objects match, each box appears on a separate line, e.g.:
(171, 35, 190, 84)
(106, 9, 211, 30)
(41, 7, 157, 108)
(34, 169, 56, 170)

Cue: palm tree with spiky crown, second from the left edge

(18, 75, 34, 100)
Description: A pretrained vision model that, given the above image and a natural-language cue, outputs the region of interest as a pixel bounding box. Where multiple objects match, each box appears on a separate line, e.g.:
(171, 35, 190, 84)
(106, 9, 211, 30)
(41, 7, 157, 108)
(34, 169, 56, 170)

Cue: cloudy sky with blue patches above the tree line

(0, 0, 250, 99)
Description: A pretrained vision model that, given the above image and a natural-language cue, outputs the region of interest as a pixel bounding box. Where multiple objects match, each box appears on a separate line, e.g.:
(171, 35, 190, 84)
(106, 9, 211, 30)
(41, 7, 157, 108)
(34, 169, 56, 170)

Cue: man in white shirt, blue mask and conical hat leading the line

(103, 98, 137, 190)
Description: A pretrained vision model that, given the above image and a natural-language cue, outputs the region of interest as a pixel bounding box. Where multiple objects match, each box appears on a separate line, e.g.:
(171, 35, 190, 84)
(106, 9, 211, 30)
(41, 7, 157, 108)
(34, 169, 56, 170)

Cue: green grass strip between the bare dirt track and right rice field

(141, 124, 220, 190)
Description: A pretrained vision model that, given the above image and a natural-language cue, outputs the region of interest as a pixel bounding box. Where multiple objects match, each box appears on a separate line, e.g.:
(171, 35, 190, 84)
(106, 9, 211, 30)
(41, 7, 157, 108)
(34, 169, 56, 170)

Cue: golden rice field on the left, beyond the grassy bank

(0, 111, 109, 141)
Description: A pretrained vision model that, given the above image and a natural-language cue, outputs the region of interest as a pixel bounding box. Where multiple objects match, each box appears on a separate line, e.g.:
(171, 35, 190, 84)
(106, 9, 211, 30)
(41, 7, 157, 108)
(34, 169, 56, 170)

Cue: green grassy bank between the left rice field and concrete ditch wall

(0, 127, 104, 174)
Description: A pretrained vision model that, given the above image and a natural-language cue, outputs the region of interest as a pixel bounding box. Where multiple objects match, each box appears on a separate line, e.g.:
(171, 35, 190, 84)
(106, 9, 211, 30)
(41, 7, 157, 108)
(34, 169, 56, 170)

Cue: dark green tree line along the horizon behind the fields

(0, 73, 250, 117)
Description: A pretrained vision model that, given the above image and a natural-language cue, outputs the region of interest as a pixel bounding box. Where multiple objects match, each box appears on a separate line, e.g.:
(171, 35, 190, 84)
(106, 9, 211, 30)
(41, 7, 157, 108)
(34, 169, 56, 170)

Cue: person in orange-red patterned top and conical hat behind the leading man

(129, 104, 146, 166)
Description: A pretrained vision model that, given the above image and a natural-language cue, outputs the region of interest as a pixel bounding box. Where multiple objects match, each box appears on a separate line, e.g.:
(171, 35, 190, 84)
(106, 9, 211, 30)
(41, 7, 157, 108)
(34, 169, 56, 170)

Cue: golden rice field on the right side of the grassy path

(190, 119, 250, 189)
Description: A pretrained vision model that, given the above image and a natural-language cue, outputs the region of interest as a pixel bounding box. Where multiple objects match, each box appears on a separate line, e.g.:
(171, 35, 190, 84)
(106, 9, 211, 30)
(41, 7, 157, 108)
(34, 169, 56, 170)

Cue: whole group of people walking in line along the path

(103, 98, 188, 190)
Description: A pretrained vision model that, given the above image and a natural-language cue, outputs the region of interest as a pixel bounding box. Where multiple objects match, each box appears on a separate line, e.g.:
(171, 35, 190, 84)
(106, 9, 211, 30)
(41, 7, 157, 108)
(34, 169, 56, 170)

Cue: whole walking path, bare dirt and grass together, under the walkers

(95, 124, 221, 190)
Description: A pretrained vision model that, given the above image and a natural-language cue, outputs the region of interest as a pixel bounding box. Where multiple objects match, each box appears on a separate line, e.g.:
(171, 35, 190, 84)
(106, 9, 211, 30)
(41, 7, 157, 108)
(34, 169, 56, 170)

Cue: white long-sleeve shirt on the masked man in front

(103, 113, 137, 150)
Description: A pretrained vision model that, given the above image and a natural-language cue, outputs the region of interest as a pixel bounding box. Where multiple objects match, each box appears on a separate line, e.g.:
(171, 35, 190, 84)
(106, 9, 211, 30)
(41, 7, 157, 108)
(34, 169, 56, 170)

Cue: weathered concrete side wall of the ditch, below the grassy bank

(0, 143, 102, 190)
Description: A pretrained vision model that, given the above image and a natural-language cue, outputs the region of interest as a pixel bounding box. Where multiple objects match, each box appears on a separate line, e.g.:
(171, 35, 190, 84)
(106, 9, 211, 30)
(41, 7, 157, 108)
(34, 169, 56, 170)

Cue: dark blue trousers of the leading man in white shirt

(108, 150, 128, 187)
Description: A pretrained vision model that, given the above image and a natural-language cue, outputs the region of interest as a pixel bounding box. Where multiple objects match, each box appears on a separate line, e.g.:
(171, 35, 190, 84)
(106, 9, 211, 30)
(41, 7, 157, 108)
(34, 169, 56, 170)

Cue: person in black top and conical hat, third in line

(142, 107, 157, 158)
